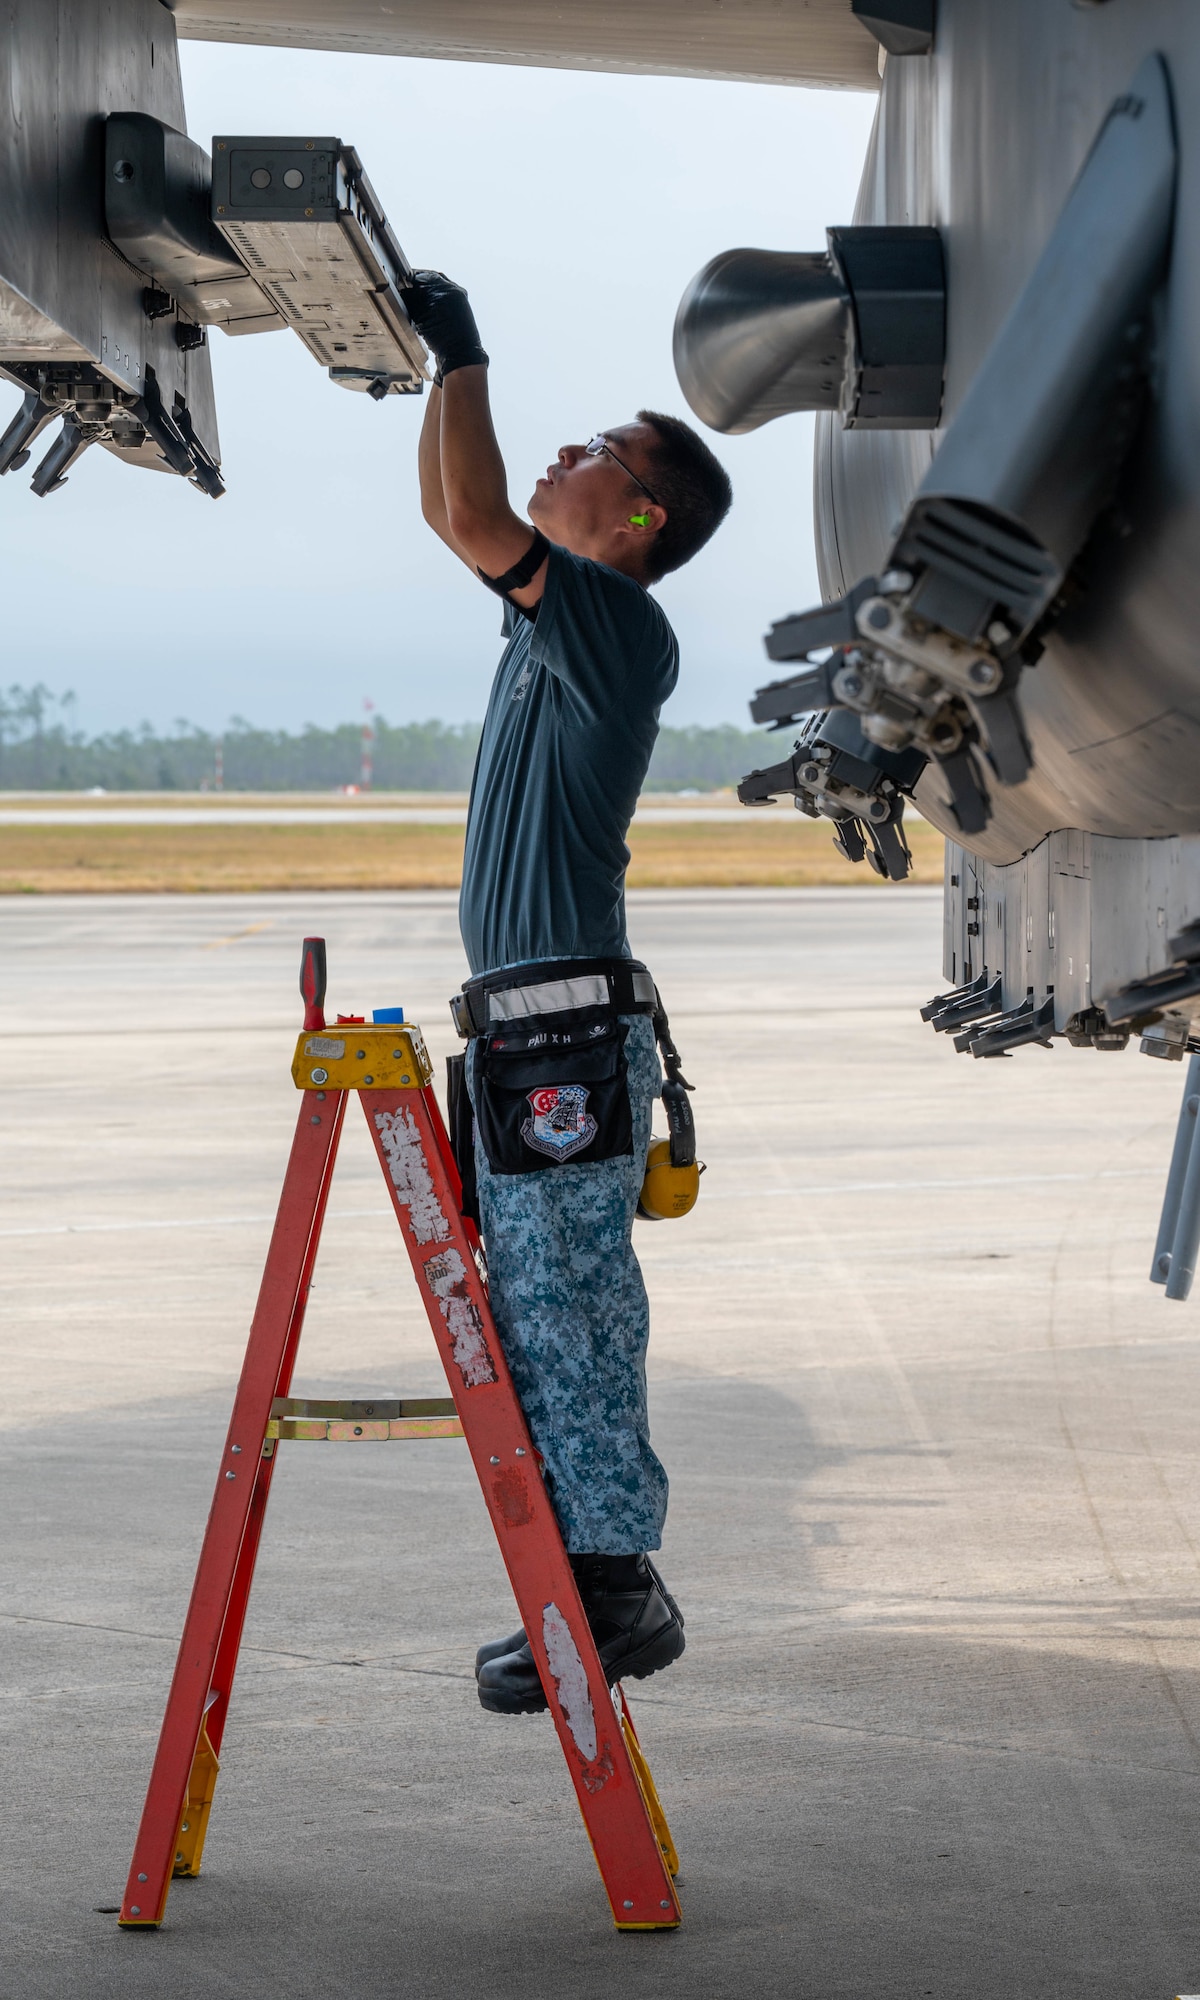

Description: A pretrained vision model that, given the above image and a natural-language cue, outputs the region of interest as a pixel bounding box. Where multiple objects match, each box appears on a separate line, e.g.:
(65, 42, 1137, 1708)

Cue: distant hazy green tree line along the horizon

(0, 682, 772, 792)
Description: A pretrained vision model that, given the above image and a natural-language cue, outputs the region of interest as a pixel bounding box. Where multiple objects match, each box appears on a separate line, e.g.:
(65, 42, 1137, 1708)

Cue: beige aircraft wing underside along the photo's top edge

(168, 0, 878, 90)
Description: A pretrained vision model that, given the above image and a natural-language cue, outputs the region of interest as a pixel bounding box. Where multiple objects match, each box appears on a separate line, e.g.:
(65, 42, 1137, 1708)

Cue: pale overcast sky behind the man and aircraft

(0, 42, 874, 730)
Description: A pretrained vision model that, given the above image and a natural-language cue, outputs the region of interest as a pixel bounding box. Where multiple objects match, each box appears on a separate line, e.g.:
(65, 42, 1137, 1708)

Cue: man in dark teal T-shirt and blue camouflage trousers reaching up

(406, 272, 732, 1714)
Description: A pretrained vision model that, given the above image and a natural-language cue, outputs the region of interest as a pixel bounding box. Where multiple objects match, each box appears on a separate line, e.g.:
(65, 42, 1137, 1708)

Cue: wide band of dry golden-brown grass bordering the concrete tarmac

(0, 810, 942, 896)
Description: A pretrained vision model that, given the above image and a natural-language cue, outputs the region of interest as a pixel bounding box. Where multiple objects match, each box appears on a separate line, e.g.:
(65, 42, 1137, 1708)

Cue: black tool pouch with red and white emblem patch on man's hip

(474, 1008, 634, 1174)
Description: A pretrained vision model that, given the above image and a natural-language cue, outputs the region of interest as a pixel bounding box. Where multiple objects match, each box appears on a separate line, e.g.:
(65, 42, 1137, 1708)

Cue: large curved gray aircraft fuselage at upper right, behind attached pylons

(820, 0, 1200, 862)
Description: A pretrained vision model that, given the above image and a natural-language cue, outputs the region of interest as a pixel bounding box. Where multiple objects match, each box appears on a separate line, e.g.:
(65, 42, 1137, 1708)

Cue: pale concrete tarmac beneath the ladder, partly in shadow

(0, 888, 1200, 2000)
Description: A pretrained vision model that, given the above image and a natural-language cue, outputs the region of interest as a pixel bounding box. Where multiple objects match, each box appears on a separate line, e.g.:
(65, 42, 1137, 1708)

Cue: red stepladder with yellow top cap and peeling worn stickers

(120, 938, 680, 1930)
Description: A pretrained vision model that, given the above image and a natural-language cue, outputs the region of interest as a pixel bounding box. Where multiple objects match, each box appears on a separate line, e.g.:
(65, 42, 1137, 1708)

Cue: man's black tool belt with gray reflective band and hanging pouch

(448, 958, 696, 1202)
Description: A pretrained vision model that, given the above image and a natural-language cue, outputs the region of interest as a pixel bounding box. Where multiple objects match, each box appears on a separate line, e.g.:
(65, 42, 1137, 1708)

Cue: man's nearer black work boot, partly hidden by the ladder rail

(478, 1556, 684, 1716)
